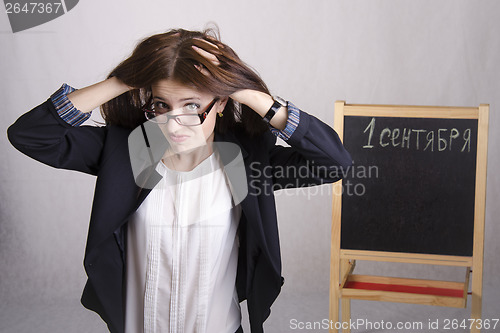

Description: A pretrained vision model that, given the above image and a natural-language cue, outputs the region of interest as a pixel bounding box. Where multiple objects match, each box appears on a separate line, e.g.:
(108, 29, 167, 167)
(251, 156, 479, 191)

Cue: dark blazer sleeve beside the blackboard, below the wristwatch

(269, 105, 352, 190)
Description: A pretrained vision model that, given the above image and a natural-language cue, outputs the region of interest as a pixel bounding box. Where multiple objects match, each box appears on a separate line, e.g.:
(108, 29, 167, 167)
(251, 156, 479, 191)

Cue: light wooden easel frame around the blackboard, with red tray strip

(330, 101, 489, 333)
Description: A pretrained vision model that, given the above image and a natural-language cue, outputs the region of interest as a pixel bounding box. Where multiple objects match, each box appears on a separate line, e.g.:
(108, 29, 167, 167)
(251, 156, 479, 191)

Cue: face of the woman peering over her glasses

(151, 80, 225, 153)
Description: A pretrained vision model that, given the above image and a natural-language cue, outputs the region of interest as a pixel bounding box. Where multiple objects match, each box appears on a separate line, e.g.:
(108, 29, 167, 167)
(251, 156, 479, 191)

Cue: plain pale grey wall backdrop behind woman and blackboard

(0, 0, 500, 333)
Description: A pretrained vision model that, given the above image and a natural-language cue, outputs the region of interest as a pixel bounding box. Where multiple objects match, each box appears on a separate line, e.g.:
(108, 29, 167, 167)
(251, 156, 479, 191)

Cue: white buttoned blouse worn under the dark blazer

(125, 154, 241, 333)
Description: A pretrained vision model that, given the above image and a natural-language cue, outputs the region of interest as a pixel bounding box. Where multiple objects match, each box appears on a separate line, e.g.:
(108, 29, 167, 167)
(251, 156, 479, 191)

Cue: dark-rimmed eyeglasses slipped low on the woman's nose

(144, 98, 218, 126)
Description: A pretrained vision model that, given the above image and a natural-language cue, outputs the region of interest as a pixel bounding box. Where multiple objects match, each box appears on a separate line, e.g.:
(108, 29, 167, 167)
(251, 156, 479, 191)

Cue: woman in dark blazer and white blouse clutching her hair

(8, 30, 351, 333)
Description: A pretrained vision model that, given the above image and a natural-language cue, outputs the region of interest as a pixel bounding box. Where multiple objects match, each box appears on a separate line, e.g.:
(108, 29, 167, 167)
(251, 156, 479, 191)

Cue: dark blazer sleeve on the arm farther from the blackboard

(7, 99, 107, 175)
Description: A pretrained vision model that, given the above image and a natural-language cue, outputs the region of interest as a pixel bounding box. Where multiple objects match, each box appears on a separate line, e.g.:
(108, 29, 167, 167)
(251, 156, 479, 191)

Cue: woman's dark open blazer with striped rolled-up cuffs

(8, 99, 352, 332)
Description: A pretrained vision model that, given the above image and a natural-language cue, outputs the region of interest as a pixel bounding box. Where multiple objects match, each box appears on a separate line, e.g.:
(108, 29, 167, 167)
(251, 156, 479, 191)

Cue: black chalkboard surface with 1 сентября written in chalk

(341, 116, 478, 256)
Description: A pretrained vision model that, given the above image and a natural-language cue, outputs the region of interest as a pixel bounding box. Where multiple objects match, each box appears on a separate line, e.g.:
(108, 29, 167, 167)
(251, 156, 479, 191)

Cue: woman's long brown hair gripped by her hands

(101, 29, 269, 134)
